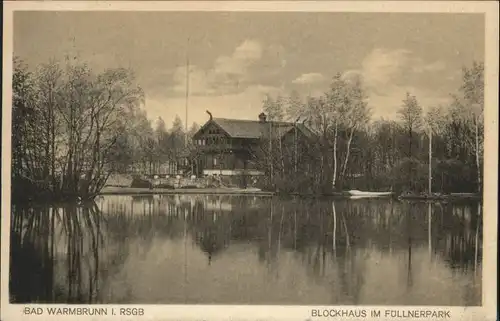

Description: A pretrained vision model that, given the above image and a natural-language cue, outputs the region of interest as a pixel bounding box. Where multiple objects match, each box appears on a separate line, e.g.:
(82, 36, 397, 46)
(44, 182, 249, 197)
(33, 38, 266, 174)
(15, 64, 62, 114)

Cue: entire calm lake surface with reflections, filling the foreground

(10, 195, 482, 306)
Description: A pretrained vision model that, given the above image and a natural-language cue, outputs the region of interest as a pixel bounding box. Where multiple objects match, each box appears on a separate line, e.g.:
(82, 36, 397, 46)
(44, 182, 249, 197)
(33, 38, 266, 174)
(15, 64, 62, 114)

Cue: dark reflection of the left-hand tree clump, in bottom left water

(9, 203, 103, 303)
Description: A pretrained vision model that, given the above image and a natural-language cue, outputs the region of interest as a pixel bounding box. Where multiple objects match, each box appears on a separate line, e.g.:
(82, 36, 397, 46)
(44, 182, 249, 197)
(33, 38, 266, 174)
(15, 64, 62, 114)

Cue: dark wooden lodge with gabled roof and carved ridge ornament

(191, 111, 315, 176)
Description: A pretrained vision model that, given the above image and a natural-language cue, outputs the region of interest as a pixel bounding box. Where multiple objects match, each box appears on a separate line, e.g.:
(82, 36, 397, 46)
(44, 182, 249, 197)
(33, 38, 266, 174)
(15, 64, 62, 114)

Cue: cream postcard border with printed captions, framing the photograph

(0, 1, 499, 321)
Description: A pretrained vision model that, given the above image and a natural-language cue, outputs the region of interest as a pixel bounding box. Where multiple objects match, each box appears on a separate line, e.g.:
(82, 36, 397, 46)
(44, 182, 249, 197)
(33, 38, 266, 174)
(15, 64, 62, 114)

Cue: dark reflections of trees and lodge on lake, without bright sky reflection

(10, 195, 482, 304)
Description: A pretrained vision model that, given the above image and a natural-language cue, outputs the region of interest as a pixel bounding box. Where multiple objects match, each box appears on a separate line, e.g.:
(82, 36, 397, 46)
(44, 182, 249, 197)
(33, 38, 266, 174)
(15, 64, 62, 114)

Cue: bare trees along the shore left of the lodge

(11, 57, 197, 201)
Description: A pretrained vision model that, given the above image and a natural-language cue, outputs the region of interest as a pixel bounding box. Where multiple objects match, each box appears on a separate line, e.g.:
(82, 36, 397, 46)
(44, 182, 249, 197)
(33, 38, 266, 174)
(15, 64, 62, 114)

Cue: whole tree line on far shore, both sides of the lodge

(12, 58, 484, 200)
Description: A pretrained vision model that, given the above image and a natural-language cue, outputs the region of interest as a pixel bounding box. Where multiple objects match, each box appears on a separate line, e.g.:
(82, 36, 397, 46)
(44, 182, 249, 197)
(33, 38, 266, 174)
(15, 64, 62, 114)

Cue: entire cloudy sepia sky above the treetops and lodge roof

(13, 11, 485, 129)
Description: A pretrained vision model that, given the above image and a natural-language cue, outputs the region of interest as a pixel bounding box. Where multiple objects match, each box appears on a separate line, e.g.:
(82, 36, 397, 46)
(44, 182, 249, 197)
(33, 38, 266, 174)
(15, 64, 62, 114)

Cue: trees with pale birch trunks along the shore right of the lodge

(256, 62, 484, 193)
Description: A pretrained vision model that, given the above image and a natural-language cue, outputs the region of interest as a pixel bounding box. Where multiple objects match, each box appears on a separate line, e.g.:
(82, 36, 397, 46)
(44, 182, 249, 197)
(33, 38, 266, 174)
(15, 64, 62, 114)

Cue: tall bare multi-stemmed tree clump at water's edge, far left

(13, 56, 143, 198)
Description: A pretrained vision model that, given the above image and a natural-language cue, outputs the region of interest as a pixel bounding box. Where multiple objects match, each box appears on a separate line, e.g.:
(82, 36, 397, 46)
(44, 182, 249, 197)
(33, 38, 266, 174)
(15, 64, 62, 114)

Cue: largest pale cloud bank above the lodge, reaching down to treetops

(145, 40, 286, 126)
